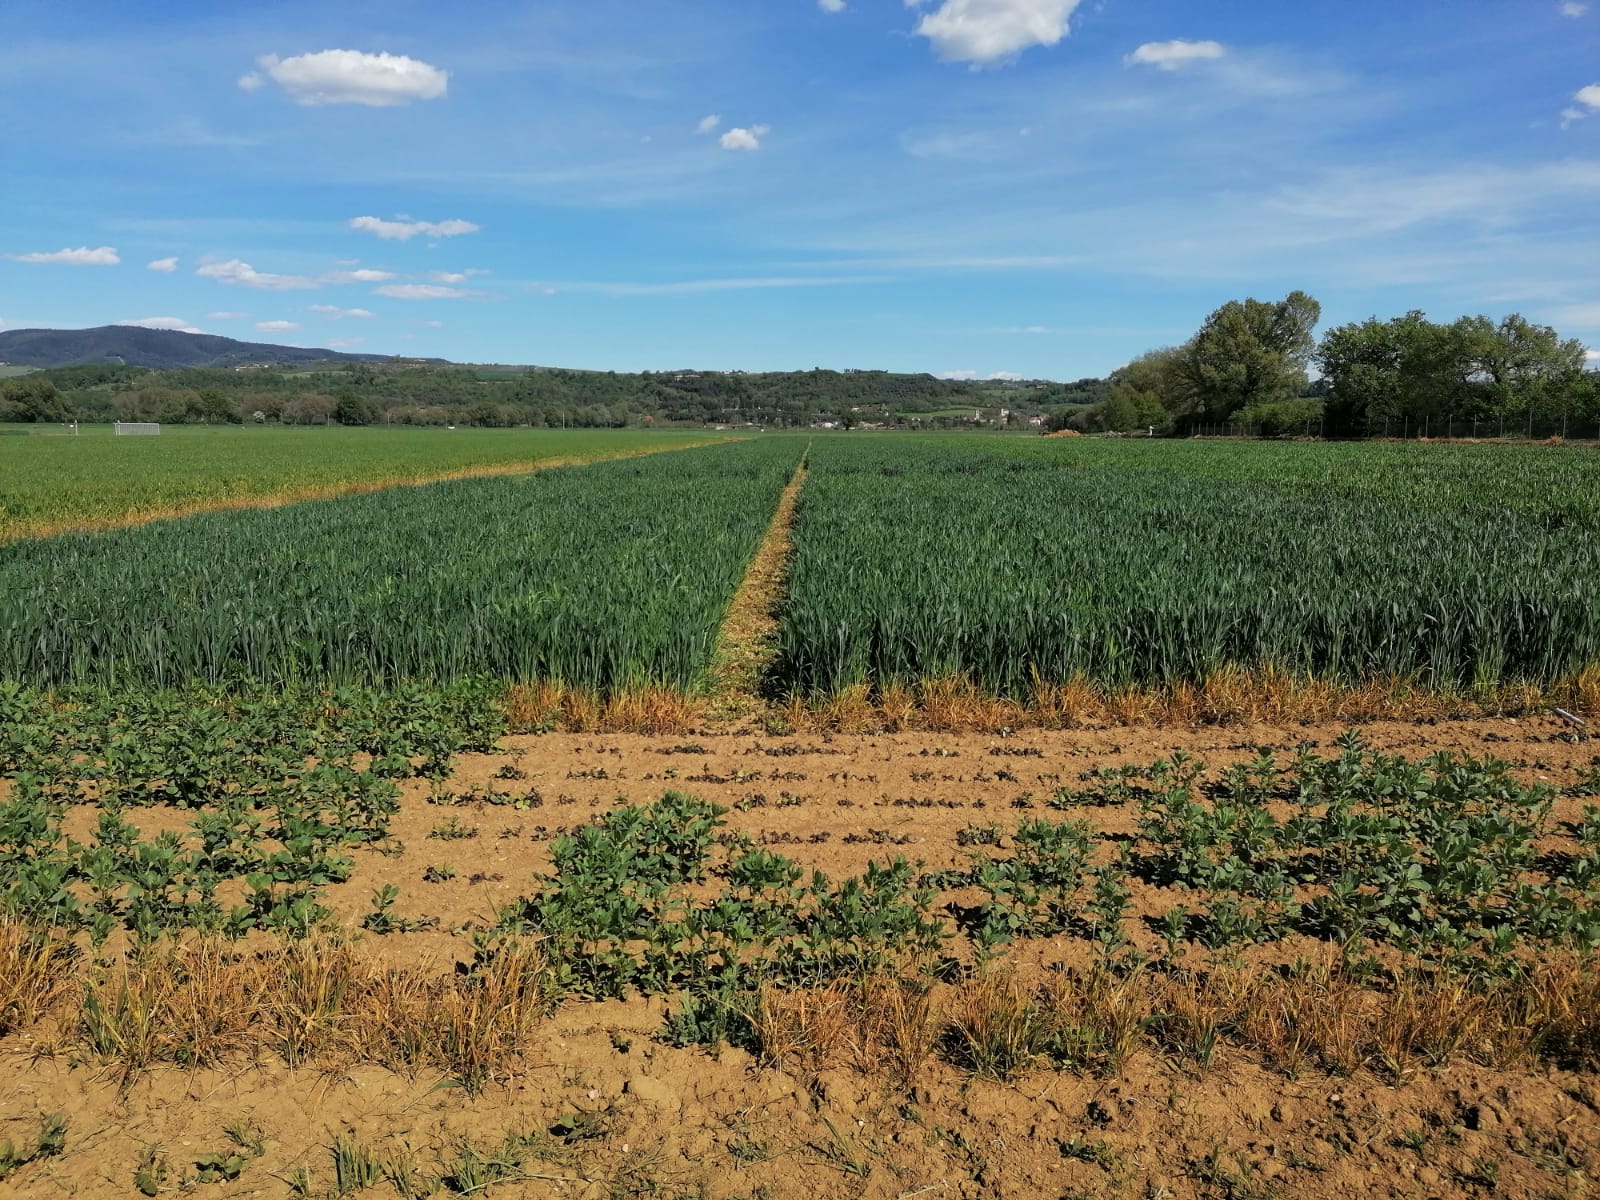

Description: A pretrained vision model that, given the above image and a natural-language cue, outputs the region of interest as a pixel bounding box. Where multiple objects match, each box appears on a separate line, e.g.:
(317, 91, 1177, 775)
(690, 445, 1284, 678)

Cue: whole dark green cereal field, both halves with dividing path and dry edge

(0, 437, 1600, 728)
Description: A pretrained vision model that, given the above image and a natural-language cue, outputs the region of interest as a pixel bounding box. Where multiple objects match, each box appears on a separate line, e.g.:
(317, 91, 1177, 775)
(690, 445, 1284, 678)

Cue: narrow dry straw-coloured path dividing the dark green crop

(704, 451, 810, 730)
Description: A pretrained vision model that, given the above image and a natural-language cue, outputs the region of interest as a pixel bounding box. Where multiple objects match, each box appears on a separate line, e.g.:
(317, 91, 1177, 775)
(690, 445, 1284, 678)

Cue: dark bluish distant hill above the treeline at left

(0, 325, 445, 370)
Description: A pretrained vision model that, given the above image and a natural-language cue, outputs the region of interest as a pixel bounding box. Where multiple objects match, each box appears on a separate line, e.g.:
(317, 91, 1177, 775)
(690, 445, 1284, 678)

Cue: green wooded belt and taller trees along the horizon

(0, 299, 1600, 438)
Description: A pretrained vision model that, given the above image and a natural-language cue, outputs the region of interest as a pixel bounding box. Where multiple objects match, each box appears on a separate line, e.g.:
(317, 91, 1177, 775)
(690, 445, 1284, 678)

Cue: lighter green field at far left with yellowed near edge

(0, 426, 712, 541)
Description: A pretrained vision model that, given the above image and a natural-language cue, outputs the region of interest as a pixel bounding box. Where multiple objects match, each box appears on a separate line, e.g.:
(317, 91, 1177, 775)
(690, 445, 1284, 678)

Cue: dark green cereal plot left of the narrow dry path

(0, 440, 805, 691)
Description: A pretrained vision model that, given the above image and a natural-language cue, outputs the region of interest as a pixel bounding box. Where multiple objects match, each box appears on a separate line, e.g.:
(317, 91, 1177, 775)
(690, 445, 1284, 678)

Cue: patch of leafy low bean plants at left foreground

(0, 683, 506, 941)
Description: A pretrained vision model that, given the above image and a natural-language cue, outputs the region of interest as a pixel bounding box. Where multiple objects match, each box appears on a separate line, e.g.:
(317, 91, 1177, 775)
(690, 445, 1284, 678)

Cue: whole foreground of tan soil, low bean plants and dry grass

(0, 713, 1600, 1197)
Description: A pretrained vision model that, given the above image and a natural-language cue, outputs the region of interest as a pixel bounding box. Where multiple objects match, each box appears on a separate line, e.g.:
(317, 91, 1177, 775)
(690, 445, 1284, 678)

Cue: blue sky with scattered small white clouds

(0, 0, 1600, 379)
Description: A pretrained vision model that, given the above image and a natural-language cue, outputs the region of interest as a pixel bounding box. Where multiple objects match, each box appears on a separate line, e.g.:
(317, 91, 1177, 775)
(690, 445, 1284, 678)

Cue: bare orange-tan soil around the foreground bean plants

(0, 717, 1600, 1200)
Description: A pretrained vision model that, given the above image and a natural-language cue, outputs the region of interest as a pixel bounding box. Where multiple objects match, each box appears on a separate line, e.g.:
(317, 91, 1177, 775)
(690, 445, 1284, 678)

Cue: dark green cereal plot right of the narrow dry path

(776, 438, 1600, 698)
